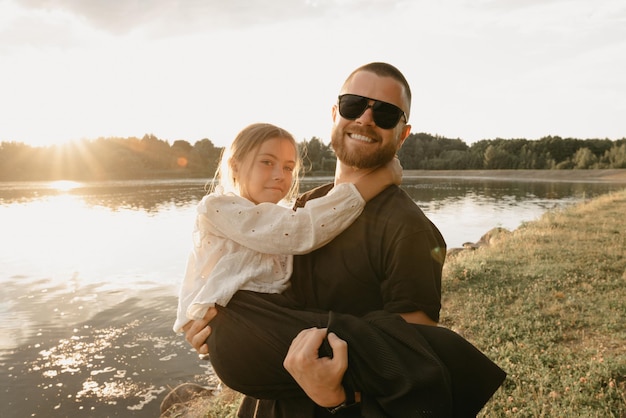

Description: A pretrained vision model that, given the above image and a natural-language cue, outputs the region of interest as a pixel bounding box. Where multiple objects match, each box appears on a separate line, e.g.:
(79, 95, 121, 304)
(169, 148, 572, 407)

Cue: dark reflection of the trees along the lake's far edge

(0, 177, 623, 213)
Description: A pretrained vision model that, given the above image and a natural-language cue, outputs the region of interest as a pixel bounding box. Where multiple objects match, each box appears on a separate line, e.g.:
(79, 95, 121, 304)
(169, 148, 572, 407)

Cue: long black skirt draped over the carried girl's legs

(207, 291, 506, 417)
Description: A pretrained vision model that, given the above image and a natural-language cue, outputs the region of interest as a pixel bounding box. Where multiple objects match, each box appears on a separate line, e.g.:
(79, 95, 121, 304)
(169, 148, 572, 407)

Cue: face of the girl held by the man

(234, 138, 296, 204)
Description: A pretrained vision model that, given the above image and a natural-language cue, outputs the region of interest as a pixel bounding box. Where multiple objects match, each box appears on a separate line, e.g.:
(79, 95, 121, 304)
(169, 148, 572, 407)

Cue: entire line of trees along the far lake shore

(0, 133, 626, 181)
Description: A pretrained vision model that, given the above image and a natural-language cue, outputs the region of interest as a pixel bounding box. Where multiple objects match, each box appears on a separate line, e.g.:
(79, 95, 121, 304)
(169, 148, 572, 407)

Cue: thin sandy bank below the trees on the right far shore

(403, 169, 626, 183)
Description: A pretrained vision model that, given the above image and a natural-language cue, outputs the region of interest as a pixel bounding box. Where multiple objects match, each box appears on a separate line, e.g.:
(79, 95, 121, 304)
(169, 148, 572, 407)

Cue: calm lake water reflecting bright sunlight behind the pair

(0, 177, 625, 418)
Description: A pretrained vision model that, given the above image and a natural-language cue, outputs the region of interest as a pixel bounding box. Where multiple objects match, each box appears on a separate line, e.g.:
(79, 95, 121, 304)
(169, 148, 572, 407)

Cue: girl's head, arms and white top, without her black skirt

(174, 123, 401, 332)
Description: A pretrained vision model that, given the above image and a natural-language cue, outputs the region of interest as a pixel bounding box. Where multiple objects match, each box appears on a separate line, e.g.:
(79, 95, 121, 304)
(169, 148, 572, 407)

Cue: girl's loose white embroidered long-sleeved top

(174, 183, 365, 332)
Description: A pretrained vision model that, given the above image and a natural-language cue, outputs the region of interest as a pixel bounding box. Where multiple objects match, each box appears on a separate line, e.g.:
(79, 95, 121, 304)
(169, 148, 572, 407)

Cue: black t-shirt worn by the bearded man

(286, 184, 446, 321)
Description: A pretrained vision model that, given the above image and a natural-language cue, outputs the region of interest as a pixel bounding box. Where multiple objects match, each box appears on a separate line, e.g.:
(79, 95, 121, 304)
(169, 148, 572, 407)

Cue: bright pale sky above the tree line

(0, 0, 626, 146)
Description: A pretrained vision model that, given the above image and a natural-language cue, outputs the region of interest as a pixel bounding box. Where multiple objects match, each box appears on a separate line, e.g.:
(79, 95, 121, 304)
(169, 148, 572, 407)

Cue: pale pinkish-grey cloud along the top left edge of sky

(0, 0, 412, 52)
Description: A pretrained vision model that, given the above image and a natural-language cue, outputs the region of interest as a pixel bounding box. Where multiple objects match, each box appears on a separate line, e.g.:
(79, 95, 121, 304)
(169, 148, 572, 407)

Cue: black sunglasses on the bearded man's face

(339, 94, 408, 129)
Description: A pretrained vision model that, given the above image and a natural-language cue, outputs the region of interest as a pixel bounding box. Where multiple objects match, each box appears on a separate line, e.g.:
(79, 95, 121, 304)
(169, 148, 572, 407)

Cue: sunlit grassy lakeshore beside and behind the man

(196, 190, 626, 418)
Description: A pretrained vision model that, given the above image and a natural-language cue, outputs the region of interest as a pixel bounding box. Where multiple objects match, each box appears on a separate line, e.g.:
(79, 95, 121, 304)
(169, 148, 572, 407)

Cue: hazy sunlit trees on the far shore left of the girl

(0, 134, 221, 180)
